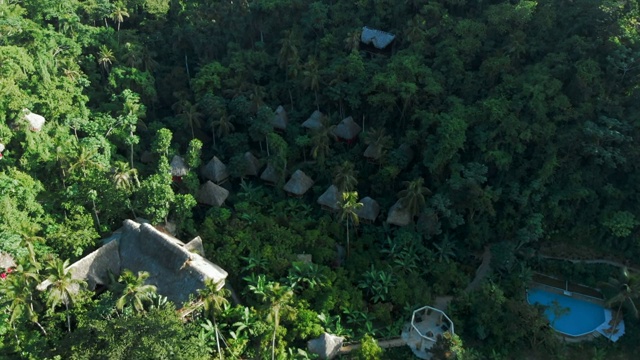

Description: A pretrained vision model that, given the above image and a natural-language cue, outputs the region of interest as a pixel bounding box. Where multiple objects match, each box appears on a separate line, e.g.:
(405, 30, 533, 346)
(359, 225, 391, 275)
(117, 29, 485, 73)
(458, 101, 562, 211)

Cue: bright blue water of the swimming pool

(527, 289, 604, 336)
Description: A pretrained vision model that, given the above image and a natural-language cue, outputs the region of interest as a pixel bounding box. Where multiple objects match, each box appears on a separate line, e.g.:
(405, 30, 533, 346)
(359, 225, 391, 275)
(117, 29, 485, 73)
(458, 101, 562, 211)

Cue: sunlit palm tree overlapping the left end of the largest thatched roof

(45, 258, 87, 332)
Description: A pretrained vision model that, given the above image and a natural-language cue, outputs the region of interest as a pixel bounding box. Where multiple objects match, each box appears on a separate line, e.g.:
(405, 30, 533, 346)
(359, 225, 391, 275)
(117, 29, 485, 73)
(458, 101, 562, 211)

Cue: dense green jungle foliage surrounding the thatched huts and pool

(0, 0, 640, 359)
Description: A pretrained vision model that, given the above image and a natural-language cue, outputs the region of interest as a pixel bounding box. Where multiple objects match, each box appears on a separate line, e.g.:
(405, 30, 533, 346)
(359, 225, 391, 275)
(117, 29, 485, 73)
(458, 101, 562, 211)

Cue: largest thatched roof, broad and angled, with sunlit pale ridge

(38, 220, 228, 307)
